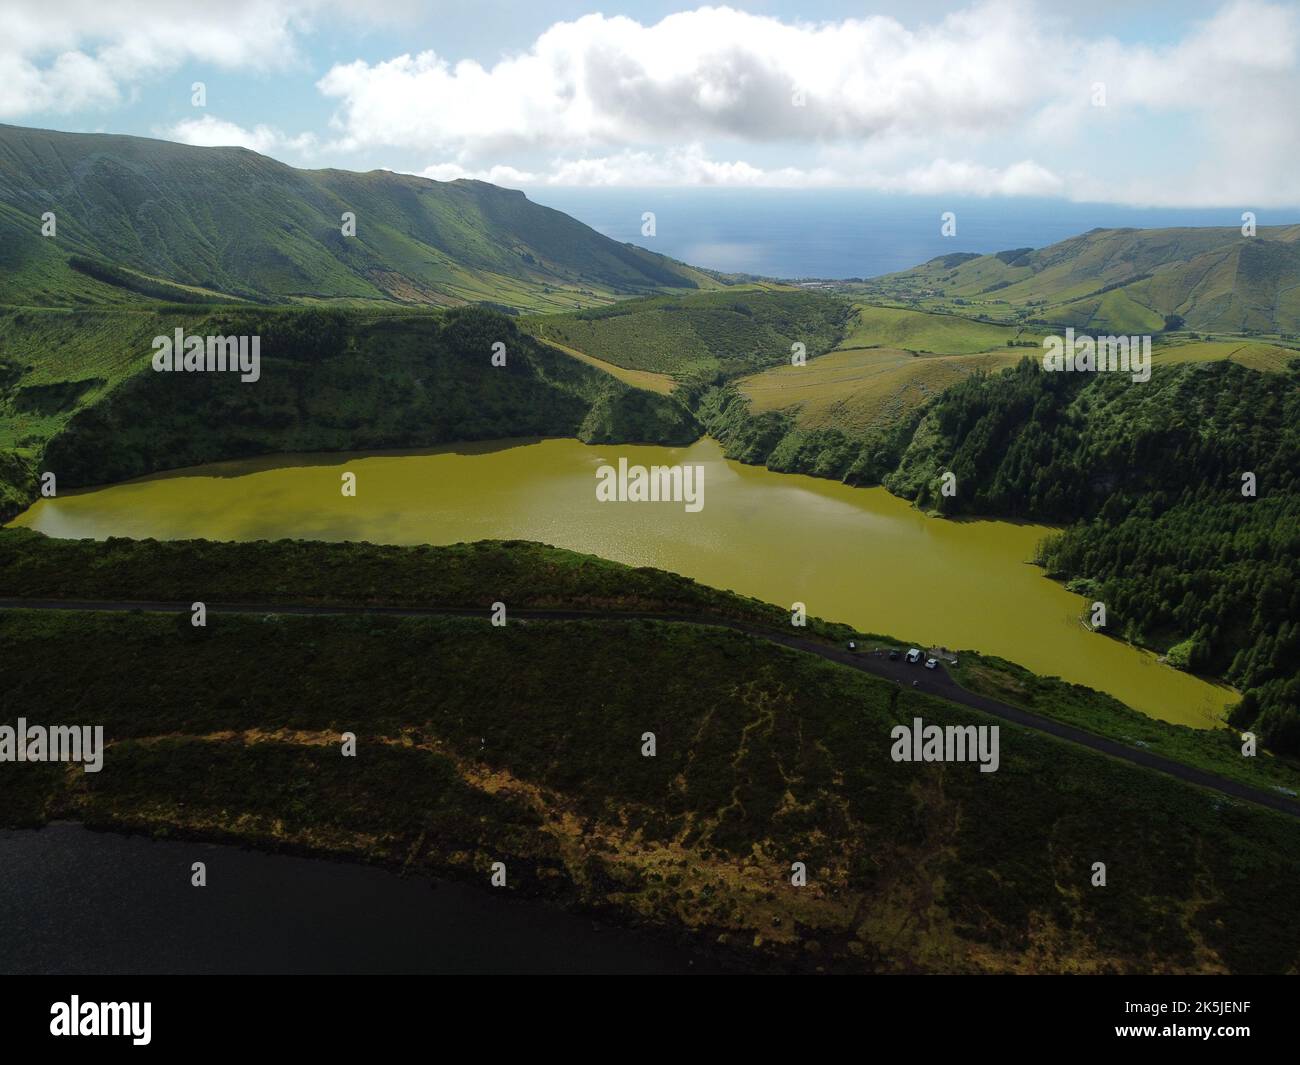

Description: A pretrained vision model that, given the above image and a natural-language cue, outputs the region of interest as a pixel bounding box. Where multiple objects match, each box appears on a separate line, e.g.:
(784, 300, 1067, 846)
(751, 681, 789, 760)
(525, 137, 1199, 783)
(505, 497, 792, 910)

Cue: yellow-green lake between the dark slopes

(13, 440, 1235, 727)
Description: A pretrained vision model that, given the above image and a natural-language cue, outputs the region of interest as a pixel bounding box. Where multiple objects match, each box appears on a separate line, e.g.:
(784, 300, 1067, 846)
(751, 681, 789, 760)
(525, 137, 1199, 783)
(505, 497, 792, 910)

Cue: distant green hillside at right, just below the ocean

(862, 225, 1300, 338)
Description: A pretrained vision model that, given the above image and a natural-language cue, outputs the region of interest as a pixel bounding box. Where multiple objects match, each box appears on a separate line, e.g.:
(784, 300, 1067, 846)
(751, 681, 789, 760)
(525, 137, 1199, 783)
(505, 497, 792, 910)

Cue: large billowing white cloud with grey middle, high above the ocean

(319, 0, 1056, 151)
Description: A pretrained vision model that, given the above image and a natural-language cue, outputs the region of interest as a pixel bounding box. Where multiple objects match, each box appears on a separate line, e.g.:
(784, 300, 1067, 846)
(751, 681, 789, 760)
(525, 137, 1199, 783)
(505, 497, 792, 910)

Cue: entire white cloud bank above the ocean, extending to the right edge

(325, 0, 1300, 204)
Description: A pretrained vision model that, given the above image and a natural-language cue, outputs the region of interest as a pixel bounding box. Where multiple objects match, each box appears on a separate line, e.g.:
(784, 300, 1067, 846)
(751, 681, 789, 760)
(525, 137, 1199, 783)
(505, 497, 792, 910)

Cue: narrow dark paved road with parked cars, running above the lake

(0, 598, 1300, 817)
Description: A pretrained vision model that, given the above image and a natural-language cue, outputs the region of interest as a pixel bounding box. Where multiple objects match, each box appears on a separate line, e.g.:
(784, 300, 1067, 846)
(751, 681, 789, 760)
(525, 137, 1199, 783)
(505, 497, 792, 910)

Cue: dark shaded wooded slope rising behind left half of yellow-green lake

(0, 307, 699, 498)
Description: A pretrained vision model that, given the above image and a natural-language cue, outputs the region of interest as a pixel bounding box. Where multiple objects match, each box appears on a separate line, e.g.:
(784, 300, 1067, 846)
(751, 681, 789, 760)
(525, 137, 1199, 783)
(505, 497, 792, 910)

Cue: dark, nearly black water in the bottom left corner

(0, 824, 711, 974)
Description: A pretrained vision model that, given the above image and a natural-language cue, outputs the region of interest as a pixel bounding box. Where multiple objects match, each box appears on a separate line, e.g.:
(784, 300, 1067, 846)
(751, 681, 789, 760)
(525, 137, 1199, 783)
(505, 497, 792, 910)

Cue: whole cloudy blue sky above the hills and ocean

(0, 0, 1300, 208)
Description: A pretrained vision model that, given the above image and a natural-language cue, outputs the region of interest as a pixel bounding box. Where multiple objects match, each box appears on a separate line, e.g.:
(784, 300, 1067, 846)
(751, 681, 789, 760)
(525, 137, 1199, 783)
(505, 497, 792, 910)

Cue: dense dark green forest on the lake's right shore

(885, 360, 1300, 753)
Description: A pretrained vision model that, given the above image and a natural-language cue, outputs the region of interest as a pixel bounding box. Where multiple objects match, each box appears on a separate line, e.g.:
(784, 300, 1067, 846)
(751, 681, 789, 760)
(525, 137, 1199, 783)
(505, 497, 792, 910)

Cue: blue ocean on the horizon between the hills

(525, 187, 1300, 278)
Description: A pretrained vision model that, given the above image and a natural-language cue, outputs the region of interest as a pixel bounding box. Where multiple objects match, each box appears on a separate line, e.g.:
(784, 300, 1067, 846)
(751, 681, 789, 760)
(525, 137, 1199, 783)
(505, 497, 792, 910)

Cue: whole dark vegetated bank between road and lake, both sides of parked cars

(10, 529, 1300, 806)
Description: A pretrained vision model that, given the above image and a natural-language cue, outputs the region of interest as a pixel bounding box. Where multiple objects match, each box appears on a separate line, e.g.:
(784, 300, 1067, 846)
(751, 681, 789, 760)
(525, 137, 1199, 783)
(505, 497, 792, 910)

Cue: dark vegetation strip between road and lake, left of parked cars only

(0, 529, 811, 640)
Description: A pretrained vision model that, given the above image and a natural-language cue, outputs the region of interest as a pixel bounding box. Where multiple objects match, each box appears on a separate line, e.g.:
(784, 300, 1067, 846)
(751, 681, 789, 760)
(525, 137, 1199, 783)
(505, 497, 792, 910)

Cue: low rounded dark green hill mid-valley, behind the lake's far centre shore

(521, 286, 849, 378)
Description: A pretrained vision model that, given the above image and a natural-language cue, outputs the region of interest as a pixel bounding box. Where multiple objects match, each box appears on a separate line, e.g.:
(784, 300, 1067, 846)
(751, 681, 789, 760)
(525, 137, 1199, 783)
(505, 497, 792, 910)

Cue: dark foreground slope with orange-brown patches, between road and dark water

(0, 537, 1300, 973)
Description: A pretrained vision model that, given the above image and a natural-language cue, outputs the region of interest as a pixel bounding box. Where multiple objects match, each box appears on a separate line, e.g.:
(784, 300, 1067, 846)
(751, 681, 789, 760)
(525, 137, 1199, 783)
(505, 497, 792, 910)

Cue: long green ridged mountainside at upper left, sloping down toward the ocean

(0, 125, 718, 311)
